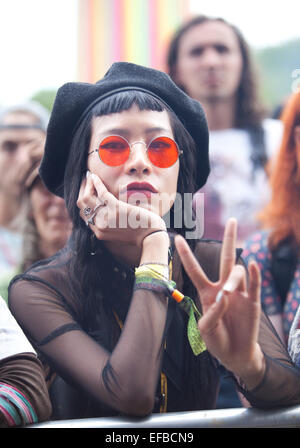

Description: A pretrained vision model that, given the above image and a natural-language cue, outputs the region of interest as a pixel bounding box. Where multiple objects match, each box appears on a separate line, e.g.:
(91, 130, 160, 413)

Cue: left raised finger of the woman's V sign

(175, 235, 212, 294)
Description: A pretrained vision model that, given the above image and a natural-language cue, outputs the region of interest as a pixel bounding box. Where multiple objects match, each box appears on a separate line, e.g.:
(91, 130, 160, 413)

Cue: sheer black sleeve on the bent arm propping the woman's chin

(9, 270, 167, 415)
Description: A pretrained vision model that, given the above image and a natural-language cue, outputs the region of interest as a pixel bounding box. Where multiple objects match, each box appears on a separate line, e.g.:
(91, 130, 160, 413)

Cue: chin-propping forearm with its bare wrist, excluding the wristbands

(109, 232, 169, 414)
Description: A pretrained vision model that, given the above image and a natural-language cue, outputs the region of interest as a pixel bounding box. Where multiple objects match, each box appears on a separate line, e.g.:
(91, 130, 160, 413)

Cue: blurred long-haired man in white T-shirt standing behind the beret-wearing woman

(167, 16, 282, 243)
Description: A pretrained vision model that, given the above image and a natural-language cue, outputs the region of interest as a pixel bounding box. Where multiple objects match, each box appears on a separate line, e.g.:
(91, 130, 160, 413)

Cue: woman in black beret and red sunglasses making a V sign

(9, 63, 300, 419)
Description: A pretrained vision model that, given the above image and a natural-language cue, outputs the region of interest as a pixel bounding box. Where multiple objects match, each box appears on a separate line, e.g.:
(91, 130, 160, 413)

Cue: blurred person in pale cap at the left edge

(0, 102, 49, 274)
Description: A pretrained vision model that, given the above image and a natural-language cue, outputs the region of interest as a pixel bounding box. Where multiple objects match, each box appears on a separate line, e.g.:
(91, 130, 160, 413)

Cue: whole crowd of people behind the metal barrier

(0, 16, 300, 426)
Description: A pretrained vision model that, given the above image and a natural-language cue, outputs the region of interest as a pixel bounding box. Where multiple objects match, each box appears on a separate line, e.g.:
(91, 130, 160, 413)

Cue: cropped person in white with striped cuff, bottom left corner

(0, 297, 51, 428)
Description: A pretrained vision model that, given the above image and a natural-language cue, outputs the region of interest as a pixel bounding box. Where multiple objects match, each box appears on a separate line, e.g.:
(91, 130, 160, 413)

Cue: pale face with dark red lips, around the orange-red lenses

(88, 105, 179, 216)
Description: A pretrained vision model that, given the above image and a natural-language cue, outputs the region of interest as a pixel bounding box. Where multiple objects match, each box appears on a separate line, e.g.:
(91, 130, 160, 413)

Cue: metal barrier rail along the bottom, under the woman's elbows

(27, 406, 300, 428)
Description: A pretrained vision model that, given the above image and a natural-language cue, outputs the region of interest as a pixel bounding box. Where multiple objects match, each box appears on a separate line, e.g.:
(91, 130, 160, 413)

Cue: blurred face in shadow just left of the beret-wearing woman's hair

(30, 178, 71, 250)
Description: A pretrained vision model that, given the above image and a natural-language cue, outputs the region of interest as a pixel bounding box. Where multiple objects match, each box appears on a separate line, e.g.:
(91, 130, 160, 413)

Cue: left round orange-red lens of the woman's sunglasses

(99, 135, 130, 166)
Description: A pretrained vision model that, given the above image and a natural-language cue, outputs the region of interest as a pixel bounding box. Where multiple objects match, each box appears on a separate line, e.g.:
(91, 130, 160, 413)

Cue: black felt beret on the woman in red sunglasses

(40, 62, 209, 196)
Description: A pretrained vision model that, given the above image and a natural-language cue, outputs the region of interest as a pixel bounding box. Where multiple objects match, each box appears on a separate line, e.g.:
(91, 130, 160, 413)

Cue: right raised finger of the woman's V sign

(220, 218, 237, 283)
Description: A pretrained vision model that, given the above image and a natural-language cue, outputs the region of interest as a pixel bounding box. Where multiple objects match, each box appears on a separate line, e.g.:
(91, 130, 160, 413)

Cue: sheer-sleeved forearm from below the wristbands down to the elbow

(103, 290, 167, 415)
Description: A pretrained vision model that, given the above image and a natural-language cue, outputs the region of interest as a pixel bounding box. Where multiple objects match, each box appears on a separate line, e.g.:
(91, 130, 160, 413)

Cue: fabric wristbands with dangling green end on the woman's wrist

(134, 263, 206, 356)
